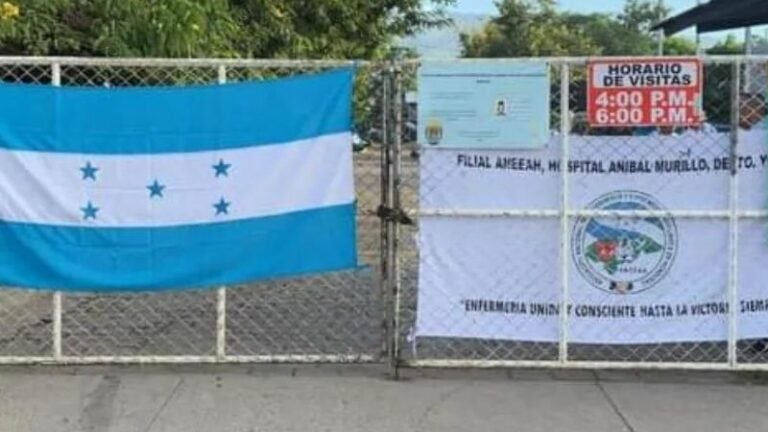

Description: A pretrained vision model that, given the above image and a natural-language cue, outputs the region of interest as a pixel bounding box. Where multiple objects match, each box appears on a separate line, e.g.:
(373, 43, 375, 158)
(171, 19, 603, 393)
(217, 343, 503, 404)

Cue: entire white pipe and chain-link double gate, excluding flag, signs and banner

(0, 56, 768, 370)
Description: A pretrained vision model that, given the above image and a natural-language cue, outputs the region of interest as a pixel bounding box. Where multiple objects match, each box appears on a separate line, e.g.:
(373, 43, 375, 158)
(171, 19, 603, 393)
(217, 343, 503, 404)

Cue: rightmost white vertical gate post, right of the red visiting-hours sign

(728, 59, 741, 367)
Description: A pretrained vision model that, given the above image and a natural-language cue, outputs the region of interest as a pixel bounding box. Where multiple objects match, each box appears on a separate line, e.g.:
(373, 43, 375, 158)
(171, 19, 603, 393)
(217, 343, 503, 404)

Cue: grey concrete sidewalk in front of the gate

(0, 366, 768, 432)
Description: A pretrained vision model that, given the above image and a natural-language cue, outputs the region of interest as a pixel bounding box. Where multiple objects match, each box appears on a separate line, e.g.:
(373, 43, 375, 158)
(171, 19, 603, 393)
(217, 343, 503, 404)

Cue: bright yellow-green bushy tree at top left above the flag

(0, 0, 243, 57)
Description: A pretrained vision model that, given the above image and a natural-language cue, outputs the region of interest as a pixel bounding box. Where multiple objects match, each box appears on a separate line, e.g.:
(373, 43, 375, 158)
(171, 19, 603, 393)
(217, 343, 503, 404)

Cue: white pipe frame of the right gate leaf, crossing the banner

(394, 55, 768, 371)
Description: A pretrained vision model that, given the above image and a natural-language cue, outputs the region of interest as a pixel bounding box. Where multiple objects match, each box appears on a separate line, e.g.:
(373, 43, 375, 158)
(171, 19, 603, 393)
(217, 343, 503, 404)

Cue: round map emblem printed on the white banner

(571, 191, 677, 294)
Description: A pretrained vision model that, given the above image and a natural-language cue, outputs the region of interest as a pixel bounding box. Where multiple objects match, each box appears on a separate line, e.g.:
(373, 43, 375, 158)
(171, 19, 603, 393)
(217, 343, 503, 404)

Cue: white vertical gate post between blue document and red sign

(558, 62, 571, 364)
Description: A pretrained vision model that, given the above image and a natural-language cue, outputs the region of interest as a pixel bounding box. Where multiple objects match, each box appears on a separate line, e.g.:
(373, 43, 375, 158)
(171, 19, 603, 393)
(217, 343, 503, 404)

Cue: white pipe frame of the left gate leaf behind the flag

(0, 56, 388, 366)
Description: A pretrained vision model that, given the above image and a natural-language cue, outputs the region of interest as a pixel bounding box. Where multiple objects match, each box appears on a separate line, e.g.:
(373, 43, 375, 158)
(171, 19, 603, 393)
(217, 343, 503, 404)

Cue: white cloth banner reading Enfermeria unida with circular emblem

(416, 131, 768, 344)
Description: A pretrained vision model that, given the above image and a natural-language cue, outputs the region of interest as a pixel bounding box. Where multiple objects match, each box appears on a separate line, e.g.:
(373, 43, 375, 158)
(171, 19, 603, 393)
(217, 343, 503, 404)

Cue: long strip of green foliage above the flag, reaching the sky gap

(0, 0, 455, 58)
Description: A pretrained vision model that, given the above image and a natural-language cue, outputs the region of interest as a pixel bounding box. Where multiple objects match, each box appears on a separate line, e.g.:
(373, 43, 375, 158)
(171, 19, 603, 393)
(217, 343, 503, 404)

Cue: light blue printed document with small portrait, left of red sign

(418, 60, 550, 149)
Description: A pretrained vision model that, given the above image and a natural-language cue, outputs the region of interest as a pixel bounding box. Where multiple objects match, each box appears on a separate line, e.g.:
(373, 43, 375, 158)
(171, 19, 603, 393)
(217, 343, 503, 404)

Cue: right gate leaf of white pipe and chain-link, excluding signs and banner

(393, 56, 768, 370)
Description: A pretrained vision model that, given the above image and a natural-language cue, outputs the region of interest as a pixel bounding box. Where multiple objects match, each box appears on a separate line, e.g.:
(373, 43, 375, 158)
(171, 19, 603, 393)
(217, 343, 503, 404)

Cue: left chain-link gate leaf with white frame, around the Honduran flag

(0, 58, 390, 363)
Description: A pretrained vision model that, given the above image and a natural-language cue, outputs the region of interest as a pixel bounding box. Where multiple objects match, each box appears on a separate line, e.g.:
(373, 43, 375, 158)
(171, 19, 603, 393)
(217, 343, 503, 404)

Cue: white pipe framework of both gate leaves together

(0, 55, 768, 370)
